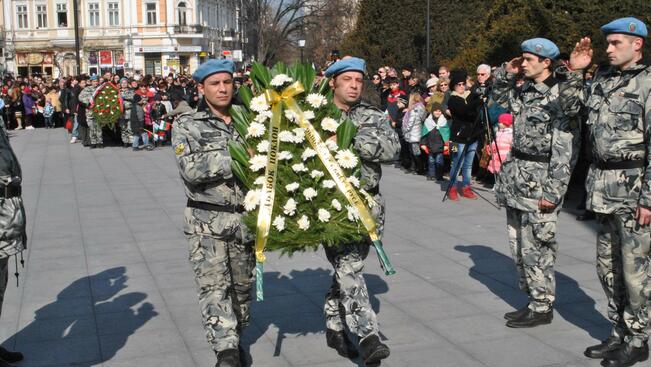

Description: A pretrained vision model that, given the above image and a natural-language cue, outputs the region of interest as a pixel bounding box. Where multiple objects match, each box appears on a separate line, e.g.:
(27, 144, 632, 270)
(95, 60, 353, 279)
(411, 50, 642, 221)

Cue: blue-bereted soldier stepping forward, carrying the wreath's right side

(325, 57, 400, 364)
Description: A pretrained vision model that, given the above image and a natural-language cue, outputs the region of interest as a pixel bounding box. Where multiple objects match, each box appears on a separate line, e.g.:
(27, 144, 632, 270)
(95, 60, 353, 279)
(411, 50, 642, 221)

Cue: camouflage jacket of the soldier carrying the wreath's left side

(172, 107, 245, 210)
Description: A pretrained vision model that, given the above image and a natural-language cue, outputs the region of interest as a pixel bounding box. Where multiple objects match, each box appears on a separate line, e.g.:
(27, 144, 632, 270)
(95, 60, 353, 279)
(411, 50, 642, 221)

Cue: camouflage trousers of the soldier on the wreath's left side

(185, 208, 255, 353)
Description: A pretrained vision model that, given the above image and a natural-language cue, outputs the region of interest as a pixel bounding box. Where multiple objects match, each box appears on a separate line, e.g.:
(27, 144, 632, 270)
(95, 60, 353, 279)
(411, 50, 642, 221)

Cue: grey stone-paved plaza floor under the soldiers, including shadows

(0, 129, 610, 367)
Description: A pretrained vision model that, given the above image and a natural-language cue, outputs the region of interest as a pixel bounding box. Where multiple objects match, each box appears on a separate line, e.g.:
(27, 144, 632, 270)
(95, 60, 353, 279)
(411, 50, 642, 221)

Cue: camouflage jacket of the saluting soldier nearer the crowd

(493, 66, 580, 212)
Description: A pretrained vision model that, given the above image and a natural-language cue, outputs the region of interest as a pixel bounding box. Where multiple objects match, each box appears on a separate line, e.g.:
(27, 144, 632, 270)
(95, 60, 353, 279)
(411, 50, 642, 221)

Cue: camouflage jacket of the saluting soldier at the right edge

(567, 64, 651, 213)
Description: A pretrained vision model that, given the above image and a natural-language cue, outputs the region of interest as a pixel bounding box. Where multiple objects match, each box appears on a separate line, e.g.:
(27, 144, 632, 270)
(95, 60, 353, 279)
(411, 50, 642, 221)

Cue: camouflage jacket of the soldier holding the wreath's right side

(342, 102, 400, 190)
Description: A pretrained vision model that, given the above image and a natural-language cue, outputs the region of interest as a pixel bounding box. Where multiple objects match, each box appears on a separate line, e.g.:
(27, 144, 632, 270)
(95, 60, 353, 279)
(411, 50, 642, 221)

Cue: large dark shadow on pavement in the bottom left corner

(3, 266, 158, 367)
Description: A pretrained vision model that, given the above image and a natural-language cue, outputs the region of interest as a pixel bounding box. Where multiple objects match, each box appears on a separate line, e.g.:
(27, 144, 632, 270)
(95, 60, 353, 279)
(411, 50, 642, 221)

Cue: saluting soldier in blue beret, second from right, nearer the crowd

(493, 38, 580, 328)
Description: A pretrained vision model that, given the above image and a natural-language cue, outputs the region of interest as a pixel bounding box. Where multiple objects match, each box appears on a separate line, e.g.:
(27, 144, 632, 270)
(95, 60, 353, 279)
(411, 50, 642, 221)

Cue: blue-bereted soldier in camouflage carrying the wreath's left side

(172, 60, 255, 367)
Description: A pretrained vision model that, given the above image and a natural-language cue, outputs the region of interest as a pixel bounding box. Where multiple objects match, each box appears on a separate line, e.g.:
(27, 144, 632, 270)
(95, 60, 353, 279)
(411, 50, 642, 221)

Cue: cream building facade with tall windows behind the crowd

(0, 0, 239, 77)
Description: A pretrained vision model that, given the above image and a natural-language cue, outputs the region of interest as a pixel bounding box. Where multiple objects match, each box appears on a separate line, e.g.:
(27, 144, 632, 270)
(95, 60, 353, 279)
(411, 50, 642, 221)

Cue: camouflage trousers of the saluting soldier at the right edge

(597, 209, 651, 347)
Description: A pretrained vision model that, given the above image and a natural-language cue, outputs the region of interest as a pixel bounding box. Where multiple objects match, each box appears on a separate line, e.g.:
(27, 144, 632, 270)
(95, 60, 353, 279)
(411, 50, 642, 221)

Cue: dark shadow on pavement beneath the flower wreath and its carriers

(243, 268, 389, 366)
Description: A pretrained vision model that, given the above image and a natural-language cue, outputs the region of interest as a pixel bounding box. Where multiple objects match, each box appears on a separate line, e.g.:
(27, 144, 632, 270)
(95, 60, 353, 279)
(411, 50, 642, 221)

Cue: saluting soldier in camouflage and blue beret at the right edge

(565, 18, 651, 367)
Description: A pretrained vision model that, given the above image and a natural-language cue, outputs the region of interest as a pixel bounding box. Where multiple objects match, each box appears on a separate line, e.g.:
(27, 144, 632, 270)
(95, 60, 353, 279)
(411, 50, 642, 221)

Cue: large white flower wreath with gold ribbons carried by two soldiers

(229, 64, 393, 299)
